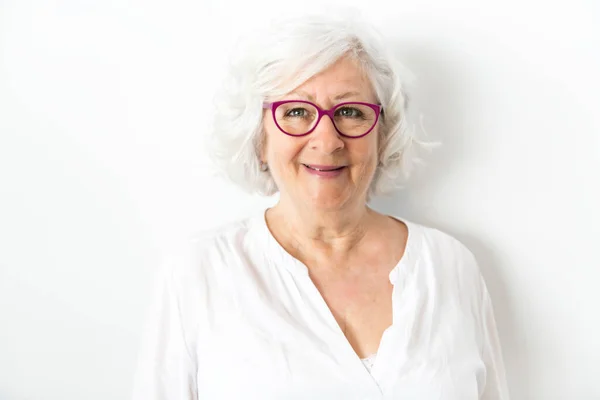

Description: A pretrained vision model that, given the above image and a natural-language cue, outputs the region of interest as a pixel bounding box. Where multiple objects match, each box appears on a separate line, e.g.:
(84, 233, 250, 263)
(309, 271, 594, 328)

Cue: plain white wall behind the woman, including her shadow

(0, 0, 600, 400)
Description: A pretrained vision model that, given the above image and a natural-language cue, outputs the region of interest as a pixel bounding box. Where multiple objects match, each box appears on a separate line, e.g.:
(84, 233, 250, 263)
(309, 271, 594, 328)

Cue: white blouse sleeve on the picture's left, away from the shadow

(133, 262, 197, 400)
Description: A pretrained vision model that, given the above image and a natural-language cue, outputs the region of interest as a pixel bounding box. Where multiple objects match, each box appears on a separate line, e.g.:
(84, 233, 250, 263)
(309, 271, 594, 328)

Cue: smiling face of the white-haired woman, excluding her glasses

(261, 58, 379, 211)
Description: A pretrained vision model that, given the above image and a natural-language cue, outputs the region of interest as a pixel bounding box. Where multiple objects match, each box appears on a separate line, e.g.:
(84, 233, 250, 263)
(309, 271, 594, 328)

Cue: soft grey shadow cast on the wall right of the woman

(371, 43, 533, 399)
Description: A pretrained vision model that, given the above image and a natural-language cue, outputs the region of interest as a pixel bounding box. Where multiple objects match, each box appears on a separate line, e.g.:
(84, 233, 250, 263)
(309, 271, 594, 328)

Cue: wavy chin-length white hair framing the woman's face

(208, 14, 432, 198)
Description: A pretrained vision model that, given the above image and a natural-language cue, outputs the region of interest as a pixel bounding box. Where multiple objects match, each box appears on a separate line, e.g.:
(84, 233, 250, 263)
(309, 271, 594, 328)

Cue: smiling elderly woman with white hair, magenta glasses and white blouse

(134, 13, 508, 400)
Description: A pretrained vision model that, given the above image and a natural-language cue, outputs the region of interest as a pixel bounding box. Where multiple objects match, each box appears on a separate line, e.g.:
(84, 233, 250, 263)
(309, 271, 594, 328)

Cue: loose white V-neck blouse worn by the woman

(133, 211, 508, 400)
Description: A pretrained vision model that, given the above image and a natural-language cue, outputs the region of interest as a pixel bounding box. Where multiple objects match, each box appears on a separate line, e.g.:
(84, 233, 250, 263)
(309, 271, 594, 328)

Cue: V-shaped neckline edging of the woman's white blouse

(259, 208, 419, 394)
